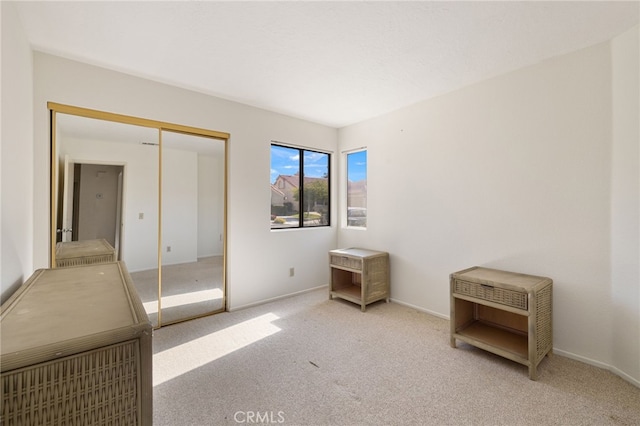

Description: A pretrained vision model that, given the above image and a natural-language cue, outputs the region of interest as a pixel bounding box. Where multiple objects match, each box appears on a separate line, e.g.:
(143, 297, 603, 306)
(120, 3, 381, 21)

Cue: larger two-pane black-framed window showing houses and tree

(271, 144, 331, 229)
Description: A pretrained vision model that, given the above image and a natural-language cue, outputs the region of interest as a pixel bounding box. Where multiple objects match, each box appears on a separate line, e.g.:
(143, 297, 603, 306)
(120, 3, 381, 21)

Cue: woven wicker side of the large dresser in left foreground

(0, 340, 141, 426)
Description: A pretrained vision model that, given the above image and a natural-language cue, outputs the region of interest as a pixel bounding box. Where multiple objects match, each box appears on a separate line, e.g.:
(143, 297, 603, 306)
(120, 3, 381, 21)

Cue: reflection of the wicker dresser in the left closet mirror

(56, 239, 116, 268)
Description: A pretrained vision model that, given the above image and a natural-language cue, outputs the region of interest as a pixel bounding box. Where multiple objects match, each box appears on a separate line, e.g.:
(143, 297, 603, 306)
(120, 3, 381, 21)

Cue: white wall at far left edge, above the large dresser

(0, 2, 33, 301)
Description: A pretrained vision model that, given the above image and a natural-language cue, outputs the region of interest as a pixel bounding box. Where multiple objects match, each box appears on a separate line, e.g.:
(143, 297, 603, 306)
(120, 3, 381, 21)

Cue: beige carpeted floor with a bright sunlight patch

(153, 289, 640, 426)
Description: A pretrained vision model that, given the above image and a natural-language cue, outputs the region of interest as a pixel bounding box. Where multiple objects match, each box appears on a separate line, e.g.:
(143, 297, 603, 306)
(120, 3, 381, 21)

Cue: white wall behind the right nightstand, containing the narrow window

(338, 36, 640, 381)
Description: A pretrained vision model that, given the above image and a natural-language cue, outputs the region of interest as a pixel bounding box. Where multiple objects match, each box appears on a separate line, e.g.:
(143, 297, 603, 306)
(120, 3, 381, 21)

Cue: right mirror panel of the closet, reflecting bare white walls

(161, 131, 225, 324)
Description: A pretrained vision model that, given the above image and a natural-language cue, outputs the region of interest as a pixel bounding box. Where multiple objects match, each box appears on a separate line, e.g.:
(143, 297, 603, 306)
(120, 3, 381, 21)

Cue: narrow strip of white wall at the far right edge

(611, 26, 640, 382)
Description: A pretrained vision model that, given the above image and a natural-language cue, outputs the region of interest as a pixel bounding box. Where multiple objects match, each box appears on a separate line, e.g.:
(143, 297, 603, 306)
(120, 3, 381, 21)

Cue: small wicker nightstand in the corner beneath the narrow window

(329, 248, 389, 312)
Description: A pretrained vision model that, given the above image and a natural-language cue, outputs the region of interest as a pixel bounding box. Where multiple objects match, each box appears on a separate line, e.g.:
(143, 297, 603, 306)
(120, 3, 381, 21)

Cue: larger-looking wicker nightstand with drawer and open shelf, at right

(450, 266, 553, 380)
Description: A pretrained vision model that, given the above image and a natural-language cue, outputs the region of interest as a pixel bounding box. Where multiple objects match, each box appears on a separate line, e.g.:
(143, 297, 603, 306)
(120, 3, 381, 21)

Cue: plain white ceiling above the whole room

(16, 1, 639, 127)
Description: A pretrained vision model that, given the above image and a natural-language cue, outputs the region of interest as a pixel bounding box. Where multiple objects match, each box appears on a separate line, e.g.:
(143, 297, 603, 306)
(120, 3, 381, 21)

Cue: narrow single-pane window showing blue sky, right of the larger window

(347, 150, 367, 228)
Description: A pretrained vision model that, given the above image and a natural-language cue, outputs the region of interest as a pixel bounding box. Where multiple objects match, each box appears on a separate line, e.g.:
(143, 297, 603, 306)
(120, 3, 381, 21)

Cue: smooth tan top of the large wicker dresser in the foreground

(0, 262, 140, 355)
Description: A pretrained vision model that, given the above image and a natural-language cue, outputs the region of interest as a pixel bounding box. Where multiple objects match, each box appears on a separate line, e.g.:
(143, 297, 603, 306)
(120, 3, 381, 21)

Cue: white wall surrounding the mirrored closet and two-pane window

(34, 52, 337, 309)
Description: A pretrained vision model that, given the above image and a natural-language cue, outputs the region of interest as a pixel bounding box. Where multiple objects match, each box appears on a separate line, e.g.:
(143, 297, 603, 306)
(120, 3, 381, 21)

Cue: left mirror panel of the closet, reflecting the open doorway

(53, 113, 159, 326)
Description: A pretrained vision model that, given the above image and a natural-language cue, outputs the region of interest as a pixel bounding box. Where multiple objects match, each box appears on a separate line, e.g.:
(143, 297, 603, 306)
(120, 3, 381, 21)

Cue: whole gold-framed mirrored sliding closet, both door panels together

(49, 103, 229, 327)
